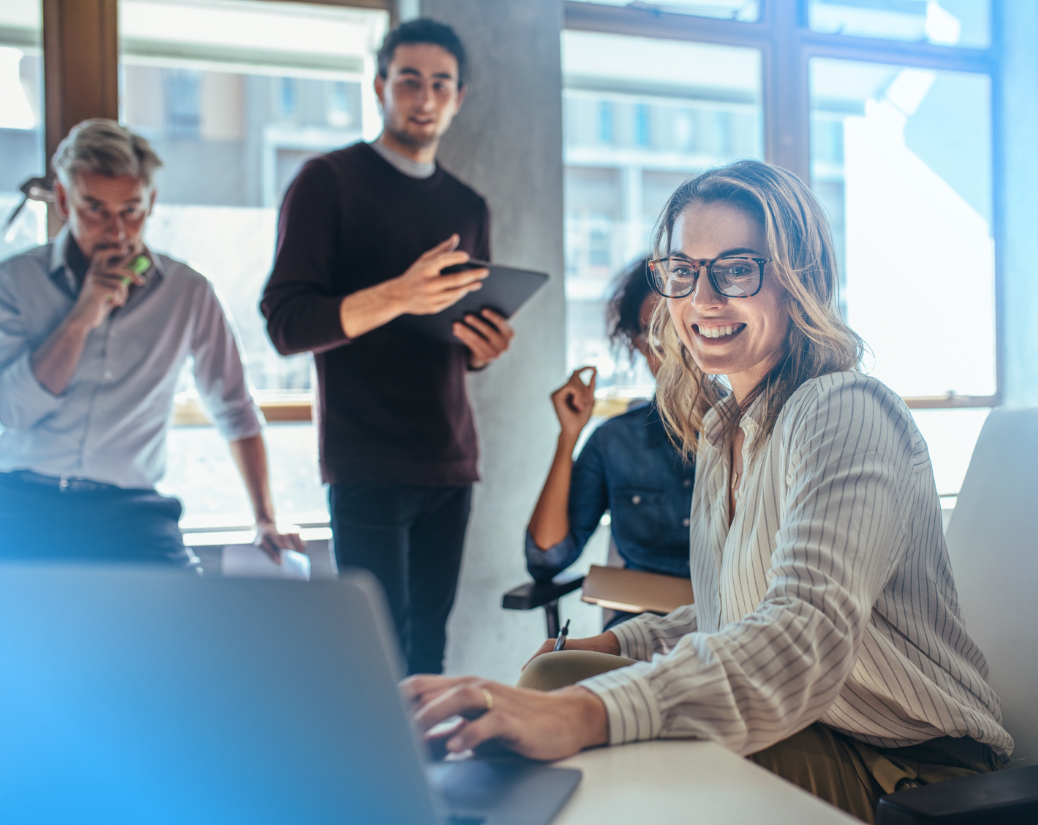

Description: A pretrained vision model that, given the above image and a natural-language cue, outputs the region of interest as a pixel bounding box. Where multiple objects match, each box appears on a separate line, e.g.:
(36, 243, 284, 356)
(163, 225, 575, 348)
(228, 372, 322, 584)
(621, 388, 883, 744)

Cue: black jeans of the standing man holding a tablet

(328, 482, 472, 673)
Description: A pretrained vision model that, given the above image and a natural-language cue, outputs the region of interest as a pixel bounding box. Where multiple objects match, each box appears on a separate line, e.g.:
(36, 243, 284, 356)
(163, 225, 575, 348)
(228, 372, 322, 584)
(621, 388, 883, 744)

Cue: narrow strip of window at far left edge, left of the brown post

(0, 0, 47, 260)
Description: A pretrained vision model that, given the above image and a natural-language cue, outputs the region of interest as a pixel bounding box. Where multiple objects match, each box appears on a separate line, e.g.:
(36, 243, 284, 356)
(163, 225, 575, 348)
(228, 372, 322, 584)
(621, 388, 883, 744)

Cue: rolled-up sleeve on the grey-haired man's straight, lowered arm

(191, 281, 263, 441)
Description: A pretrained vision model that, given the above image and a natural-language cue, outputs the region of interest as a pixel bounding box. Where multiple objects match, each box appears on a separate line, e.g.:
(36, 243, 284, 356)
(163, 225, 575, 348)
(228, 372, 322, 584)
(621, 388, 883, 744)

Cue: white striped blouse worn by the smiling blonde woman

(580, 373, 1013, 754)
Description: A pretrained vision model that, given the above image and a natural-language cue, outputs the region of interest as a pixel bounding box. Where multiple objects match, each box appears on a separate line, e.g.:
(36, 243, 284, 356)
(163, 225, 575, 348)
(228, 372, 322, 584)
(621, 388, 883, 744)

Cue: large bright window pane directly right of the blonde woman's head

(811, 59, 998, 398)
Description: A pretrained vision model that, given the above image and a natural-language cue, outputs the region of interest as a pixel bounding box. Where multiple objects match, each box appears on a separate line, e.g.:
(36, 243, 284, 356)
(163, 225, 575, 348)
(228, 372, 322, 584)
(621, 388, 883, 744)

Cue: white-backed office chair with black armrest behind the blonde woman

(876, 409, 1038, 825)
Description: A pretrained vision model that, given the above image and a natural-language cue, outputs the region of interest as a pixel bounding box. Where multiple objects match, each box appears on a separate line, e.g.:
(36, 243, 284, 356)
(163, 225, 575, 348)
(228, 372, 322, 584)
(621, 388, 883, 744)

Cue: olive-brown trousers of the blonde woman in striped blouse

(517, 651, 1002, 823)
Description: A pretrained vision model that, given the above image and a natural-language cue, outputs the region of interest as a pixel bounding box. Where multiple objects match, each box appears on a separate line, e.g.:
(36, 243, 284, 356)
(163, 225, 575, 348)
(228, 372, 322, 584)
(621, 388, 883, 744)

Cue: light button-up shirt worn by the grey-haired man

(0, 227, 262, 489)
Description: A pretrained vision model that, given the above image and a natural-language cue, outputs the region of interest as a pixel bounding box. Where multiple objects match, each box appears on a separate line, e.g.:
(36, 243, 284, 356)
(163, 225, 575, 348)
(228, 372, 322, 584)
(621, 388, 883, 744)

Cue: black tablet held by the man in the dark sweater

(393, 260, 548, 343)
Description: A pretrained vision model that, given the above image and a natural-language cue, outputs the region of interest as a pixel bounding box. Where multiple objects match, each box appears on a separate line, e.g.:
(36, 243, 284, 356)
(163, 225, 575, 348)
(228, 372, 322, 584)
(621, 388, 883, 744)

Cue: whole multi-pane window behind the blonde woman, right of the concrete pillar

(563, 0, 1002, 494)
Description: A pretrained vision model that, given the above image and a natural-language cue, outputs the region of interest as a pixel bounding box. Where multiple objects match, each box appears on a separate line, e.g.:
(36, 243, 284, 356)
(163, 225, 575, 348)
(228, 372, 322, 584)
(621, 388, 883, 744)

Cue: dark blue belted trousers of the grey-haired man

(0, 471, 197, 568)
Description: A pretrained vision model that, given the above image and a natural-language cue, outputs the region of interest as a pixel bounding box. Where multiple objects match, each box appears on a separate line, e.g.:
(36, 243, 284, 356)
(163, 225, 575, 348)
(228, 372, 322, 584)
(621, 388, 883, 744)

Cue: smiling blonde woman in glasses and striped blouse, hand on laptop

(404, 161, 1013, 822)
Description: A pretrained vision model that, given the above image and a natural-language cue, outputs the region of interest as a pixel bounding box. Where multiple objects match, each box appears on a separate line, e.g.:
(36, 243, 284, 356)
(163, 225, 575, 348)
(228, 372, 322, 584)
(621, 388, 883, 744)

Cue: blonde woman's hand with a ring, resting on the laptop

(401, 676, 609, 761)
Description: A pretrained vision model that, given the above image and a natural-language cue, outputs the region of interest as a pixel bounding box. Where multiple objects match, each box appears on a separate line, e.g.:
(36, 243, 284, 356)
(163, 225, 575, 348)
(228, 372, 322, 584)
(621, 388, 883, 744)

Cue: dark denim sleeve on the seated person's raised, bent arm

(526, 431, 609, 581)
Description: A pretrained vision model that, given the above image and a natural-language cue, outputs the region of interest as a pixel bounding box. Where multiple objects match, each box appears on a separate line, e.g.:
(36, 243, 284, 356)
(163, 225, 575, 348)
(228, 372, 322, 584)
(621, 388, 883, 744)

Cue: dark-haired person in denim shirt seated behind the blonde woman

(526, 258, 695, 629)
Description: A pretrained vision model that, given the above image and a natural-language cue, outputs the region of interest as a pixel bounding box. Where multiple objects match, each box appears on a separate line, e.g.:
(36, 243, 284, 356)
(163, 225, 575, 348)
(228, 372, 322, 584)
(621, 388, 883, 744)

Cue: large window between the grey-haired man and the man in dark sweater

(119, 0, 388, 530)
